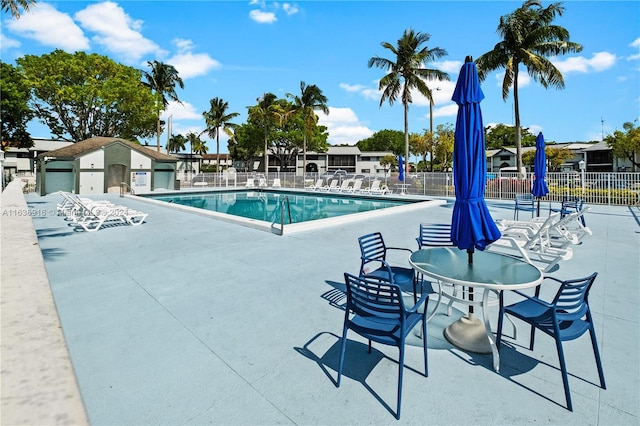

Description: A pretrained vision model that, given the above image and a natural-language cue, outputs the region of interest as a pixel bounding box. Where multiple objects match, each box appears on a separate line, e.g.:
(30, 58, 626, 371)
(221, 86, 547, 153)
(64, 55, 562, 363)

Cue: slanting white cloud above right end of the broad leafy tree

(75, 1, 162, 63)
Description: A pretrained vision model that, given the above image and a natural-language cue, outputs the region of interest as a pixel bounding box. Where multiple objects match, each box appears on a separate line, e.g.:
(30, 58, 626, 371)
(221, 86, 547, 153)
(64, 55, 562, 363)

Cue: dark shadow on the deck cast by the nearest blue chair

(294, 332, 424, 416)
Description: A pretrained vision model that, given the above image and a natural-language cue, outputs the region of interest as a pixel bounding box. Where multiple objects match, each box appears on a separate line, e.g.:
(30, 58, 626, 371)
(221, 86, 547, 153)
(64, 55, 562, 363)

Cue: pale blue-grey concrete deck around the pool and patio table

(2, 182, 640, 425)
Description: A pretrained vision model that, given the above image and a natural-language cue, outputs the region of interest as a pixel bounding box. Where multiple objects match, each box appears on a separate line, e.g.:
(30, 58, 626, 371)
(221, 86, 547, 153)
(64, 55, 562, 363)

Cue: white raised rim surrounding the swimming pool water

(125, 188, 446, 235)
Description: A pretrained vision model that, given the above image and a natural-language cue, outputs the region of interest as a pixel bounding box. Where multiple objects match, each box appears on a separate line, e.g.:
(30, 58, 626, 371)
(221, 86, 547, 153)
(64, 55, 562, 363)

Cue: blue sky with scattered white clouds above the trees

(0, 0, 640, 152)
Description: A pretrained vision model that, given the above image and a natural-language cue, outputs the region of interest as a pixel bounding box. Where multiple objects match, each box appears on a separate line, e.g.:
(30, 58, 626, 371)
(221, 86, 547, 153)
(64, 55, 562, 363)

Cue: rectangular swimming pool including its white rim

(141, 189, 440, 233)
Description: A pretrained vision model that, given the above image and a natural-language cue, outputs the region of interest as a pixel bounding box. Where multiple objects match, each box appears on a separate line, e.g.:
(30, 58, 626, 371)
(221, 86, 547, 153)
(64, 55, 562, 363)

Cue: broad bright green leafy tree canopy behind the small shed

(16, 49, 157, 142)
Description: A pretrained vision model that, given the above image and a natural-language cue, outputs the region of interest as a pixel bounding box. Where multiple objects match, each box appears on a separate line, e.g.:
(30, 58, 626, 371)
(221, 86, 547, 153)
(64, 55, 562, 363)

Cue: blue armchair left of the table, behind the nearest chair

(358, 232, 418, 301)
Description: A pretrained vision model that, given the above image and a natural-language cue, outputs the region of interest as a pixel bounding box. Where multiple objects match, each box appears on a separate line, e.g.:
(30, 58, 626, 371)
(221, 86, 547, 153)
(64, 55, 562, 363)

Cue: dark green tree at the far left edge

(0, 61, 33, 151)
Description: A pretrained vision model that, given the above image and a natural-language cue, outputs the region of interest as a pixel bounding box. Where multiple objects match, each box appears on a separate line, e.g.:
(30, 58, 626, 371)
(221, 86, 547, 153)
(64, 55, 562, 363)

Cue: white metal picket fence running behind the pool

(181, 172, 640, 205)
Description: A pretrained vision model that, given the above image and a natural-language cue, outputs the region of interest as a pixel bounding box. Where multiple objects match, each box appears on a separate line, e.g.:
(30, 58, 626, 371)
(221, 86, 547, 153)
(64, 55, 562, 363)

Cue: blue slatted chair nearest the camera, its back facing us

(336, 273, 429, 420)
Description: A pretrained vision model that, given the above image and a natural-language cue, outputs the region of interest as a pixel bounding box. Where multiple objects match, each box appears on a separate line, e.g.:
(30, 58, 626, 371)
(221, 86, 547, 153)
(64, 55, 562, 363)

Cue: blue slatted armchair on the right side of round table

(496, 272, 606, 411)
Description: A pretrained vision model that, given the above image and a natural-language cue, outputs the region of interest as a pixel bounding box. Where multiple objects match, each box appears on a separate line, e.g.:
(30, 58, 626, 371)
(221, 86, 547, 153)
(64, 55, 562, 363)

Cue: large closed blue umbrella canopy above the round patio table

(451, 56, 501, 256)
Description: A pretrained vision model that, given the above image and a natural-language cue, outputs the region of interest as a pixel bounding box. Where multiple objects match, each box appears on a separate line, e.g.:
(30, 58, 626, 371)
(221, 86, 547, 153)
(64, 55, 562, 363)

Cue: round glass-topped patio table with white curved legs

(409, 247, 543, 371)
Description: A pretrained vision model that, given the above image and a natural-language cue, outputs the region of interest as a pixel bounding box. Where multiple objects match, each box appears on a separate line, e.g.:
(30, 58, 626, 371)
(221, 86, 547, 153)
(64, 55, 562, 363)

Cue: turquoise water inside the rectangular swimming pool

(146, 190, 416, 223)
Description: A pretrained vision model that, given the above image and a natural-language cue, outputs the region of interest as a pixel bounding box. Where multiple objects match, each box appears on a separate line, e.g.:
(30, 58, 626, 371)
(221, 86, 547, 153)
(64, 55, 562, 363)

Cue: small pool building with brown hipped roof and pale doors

(36, 137, 177, 195)
